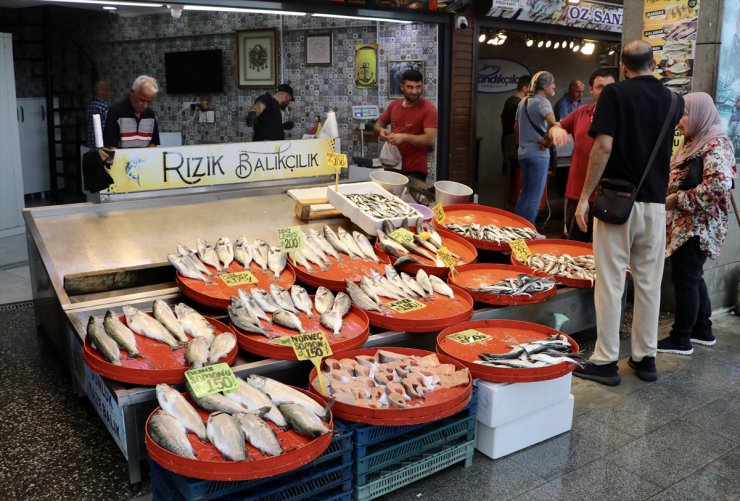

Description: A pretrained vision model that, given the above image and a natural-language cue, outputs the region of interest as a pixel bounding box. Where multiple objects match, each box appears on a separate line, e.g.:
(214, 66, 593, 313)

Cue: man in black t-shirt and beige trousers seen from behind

(574, 40, 684, 386)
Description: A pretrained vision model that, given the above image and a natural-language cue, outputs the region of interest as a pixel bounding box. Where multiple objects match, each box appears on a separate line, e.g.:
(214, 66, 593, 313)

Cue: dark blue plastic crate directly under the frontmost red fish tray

(149, 422, 352, 501)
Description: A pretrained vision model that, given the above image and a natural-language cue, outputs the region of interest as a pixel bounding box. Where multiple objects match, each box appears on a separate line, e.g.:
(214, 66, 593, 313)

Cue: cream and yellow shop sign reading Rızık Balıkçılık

(108, 139, 339, 193)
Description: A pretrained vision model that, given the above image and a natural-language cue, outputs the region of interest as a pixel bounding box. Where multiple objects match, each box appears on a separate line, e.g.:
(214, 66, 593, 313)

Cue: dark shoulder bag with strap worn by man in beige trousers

(593, 92, 678, 224)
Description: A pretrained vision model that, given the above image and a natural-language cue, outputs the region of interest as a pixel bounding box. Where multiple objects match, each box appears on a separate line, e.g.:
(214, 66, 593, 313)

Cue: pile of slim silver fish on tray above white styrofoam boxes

(475, 334, 583, 369)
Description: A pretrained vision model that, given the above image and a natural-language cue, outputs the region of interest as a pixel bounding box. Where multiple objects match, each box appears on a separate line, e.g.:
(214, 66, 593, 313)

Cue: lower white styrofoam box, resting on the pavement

(475, 395, 575, 459)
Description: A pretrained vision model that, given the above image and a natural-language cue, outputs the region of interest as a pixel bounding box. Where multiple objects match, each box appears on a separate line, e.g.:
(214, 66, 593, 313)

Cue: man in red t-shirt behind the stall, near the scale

(373, 70, 438, 181)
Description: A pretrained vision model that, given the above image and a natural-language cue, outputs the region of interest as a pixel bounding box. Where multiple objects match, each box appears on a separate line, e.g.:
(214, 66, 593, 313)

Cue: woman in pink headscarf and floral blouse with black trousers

(658, 92, 737, 355)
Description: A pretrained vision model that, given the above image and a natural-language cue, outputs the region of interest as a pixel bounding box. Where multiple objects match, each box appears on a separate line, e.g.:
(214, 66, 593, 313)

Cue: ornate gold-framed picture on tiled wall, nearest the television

(236, 28, 278, 88)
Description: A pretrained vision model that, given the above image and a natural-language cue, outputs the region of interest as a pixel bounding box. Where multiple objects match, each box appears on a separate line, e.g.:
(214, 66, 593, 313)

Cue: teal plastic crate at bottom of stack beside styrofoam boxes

(352, 441, 475, 501)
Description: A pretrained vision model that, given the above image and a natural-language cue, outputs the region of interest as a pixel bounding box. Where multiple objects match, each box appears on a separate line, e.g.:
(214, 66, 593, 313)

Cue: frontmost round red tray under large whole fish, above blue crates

(144, 388, 334, 481)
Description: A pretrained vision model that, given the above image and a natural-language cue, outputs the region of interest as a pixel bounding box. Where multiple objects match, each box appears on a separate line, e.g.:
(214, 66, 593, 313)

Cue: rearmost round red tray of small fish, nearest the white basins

(433, 204, 535, 252)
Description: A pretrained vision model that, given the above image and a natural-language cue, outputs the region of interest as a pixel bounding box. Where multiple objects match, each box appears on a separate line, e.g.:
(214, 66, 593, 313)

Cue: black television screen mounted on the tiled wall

(164, 49, 224, 94)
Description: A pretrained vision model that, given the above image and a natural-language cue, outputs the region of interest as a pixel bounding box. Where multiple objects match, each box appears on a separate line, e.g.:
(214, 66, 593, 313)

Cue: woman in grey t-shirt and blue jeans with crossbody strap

(514, 71, 568, 224)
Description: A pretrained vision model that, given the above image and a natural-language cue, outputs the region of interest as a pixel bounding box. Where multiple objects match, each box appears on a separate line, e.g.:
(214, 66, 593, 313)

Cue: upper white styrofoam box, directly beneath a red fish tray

(476, 372, 572, 427)
